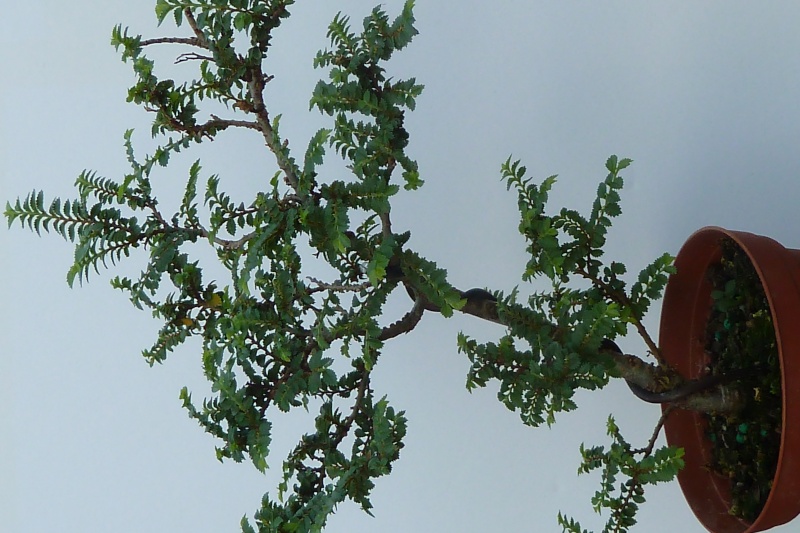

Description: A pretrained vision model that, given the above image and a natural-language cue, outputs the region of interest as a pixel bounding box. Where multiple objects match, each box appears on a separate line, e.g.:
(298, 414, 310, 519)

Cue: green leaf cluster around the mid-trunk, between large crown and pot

(459, 156, 672, 426)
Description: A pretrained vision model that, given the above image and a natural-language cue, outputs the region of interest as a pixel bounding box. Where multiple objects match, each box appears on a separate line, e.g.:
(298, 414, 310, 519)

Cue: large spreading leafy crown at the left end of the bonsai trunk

(5, 0, 434, 531)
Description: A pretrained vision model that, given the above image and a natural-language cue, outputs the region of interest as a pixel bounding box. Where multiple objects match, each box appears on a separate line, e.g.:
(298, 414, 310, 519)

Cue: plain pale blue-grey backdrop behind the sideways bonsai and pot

(0, 0, 800, 533)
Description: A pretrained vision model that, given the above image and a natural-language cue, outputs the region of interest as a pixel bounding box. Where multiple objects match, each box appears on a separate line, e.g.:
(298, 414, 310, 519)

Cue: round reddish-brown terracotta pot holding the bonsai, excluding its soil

(660, 227, 800, 533)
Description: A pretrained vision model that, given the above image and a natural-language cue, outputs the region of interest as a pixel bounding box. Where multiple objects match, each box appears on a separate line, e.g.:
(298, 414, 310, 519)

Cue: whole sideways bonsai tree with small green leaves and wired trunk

(0, 0, 788, 532)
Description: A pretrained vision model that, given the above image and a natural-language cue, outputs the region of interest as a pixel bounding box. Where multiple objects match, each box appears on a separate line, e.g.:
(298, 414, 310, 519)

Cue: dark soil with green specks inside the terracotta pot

(706, 240, 782, 522)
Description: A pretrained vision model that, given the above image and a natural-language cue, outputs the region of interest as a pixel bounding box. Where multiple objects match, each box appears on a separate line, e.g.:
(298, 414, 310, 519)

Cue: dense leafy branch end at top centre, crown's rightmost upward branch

(310, 0, 423, 189)
